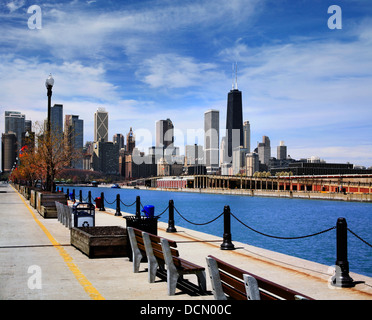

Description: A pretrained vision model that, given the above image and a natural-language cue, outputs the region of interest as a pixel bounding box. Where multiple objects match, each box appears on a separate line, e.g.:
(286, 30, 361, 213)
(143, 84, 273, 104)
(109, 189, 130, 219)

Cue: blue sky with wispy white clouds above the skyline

(0, 0, 372, 167)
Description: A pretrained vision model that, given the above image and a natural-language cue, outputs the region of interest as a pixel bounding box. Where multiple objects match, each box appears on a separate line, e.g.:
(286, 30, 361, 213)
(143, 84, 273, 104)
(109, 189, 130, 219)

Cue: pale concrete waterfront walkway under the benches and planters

(0, 184, 372, 301)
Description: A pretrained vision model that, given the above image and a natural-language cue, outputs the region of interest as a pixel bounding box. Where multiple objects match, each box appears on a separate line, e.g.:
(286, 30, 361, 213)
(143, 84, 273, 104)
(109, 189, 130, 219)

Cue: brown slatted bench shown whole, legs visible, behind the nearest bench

(127, 227, 206, 295)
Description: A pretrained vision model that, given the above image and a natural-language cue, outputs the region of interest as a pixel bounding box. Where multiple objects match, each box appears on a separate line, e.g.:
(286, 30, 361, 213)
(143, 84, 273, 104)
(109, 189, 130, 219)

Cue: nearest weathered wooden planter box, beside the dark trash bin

(71, 226, 129, 258)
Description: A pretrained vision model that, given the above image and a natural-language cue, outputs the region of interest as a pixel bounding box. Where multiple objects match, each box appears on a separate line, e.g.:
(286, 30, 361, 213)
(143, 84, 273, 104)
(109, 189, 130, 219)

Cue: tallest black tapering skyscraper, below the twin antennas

(226, 86, 244, 159)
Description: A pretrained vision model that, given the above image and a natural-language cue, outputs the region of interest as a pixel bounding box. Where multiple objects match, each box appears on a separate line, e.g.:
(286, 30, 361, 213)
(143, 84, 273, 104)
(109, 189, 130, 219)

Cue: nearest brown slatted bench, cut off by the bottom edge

(206, 255, 313, 300)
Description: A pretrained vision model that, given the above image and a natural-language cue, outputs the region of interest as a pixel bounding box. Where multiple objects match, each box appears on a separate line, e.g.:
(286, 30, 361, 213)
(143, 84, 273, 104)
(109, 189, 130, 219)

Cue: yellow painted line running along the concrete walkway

(12, 186, 105, 300)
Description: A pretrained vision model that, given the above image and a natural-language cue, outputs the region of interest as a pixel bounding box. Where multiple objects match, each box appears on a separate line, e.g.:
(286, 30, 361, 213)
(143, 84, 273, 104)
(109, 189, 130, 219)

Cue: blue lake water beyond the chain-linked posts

(65, 187, 372, 277)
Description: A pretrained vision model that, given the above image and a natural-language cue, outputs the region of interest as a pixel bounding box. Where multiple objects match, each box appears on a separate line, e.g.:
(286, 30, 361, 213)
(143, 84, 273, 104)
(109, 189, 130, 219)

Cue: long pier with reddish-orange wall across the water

(146, 174, 372, 202)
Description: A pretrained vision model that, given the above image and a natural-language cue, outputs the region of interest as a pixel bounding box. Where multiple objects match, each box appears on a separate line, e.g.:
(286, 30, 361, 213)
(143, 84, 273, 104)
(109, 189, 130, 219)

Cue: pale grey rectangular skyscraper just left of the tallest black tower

(204, 110, 220, 174)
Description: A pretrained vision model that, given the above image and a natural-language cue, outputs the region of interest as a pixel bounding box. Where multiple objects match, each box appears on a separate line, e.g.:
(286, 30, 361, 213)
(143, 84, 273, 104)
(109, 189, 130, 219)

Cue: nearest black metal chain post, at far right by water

(331, 218, 355, 288)
